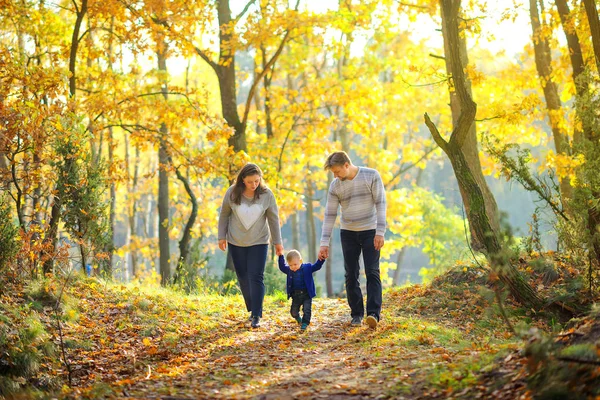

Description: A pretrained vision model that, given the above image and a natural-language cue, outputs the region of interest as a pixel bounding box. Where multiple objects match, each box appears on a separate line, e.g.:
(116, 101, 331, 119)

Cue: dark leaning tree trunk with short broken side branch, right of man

(424, 0, 543, 310)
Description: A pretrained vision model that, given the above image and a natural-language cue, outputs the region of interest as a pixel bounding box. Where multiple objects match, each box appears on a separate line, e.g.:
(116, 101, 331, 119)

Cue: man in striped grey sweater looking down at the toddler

(319, 151, 386, 329)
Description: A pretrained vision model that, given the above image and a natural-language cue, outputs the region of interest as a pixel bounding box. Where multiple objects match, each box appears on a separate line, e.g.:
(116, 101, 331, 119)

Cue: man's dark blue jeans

(340, 229, 382, 320)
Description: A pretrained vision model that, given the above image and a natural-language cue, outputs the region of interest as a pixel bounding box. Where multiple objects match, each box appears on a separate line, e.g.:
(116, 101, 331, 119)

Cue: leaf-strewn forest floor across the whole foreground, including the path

(7, 252, 600, 400)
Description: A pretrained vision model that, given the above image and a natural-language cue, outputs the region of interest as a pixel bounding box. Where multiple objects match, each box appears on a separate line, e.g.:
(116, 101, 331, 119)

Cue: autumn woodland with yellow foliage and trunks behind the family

(0, 0, 600, 396)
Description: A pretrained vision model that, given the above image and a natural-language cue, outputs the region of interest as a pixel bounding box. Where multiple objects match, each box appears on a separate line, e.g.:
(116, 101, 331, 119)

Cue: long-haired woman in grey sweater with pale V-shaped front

(219, 164, 283, 328)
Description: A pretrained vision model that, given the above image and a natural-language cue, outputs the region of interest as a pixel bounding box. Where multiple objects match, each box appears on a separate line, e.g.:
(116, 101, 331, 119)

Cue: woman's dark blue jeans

(229, 243, 269, 318)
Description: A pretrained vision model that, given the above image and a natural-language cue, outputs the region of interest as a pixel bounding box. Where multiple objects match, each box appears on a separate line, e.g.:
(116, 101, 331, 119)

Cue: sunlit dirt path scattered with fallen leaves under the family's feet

(117, 299, 429, 399)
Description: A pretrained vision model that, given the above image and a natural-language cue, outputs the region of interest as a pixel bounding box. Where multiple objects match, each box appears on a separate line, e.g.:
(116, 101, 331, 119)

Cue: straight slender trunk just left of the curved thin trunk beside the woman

(157, 40, 171, 286)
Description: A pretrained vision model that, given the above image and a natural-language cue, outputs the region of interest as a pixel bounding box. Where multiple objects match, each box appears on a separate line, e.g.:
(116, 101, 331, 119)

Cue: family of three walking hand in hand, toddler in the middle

(218, 151, 386, 330)
